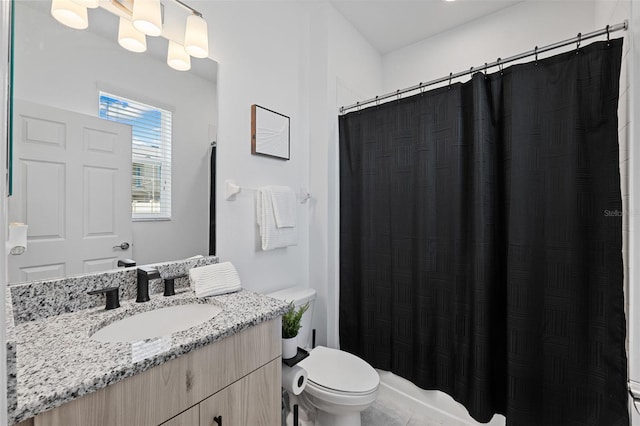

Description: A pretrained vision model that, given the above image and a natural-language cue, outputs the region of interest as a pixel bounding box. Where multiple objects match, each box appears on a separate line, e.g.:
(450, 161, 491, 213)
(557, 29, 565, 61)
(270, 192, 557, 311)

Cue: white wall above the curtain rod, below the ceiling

(383, 0, 594, 93)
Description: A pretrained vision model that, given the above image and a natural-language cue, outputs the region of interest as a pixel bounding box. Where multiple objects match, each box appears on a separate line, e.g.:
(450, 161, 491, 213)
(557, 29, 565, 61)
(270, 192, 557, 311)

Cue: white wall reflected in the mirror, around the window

(10, 2, 217, 264)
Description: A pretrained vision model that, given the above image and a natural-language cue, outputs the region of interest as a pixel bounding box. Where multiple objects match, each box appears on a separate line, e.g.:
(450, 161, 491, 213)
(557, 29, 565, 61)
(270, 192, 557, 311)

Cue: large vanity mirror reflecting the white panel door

(9, 0, 218, 282)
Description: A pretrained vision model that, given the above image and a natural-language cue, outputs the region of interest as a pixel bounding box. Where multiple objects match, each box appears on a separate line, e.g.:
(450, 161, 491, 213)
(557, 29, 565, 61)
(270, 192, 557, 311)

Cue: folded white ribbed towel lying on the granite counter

(189, 262, 242, 297)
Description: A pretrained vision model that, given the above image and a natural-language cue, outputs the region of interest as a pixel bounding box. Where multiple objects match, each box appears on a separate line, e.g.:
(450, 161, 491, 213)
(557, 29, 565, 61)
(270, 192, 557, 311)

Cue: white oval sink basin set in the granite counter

(91, 303, 222, 342)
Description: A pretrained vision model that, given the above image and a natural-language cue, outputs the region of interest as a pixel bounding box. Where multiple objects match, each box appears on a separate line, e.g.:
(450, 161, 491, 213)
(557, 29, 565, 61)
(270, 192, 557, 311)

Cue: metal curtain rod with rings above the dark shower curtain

(340, 20, 629, 114)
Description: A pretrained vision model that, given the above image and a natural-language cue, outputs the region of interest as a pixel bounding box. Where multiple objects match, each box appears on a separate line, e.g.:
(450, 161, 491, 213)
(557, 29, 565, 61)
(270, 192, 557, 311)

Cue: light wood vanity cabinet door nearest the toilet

(200, 358, 282, 426)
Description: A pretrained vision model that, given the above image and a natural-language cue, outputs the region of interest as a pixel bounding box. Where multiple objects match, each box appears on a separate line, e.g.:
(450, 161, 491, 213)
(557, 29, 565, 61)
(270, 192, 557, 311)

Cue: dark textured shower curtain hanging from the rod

(339, 39, 629, 426)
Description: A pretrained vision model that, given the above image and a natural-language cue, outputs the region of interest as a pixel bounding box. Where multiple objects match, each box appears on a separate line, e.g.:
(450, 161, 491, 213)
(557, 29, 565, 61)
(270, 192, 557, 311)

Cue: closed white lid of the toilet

(298, 346, 380, 393)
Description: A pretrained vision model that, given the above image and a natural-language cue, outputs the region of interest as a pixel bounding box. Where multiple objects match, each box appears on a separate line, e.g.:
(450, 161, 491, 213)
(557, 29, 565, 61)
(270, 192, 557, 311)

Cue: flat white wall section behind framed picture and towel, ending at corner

(197, 1, 309, 292)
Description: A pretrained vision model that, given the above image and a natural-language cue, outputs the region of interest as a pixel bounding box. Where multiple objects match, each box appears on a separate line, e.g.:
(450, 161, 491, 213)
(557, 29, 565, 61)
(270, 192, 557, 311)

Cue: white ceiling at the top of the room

(331, 0, 523, 54)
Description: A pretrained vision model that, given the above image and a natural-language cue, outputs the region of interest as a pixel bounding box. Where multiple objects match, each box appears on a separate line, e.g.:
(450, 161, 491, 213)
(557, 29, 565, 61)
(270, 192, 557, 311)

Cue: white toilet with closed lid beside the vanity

(269, 287, 380, 426)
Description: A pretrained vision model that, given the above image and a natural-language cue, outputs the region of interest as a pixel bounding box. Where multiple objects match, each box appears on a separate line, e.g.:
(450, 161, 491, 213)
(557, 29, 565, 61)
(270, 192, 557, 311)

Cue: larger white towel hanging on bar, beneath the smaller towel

(256, 187, 298, 250)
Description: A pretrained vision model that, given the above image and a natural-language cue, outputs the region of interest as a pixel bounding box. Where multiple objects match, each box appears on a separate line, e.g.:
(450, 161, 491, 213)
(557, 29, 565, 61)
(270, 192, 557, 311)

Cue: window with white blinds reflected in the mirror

(100, 92, 171, 220)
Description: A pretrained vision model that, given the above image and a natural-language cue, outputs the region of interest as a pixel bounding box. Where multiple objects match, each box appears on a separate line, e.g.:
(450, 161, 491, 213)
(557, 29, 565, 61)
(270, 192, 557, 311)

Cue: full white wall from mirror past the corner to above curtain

(198, 2, 381, 346)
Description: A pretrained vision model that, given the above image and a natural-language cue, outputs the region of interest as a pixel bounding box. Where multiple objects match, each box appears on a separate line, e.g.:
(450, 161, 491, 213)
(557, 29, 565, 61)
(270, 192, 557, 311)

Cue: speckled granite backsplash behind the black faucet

(7, 256, 218, 325)
